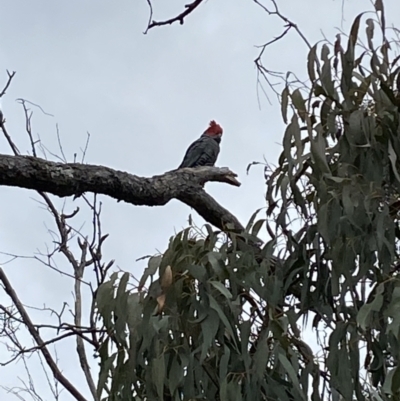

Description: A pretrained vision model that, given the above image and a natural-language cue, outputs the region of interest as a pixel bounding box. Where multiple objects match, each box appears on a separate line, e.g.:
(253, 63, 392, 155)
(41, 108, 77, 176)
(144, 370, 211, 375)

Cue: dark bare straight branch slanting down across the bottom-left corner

(0, 268, 87, 401)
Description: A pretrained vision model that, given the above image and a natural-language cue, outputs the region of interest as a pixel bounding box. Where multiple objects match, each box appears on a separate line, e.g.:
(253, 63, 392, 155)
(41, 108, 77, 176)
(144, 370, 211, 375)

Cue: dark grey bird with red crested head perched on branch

(178, 120, 223, 169)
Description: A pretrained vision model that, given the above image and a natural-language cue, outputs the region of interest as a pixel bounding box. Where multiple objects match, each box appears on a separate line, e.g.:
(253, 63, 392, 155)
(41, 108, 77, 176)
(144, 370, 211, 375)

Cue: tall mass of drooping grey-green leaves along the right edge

(267, 2, 400, 400)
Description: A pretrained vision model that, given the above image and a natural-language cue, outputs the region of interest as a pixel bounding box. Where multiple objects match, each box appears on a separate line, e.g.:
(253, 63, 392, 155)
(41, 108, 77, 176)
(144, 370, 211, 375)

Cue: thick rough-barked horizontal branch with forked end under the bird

(0, 154, 243, 231)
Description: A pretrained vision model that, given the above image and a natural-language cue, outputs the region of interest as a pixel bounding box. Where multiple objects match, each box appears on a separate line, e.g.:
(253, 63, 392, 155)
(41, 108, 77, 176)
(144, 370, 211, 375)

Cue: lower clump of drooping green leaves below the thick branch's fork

(97, 225, 318, 400)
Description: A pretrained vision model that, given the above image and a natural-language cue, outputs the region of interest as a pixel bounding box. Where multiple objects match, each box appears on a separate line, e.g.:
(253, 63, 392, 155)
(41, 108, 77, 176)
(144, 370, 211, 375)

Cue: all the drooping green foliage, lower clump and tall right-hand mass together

(97, 1, 400, 401)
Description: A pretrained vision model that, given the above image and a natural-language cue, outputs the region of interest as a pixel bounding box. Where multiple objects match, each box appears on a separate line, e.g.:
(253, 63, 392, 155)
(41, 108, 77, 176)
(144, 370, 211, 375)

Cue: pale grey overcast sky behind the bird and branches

(0, 0, 400, 400)
